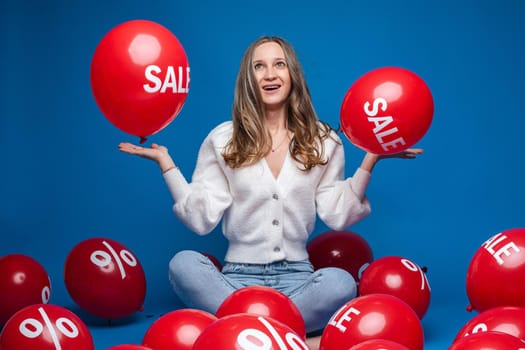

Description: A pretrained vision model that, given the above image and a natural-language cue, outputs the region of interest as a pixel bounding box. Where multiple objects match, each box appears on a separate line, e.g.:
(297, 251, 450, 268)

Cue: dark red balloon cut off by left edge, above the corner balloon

(0, 254, 51, 326)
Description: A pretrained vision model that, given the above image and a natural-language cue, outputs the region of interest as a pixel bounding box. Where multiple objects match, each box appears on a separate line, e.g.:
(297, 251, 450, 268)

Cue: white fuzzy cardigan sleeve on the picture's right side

(316, 136, 371, 230)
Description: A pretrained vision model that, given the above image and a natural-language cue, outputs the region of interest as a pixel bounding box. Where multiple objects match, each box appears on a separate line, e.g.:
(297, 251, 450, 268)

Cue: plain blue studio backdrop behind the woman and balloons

(0, 0, 525, 349)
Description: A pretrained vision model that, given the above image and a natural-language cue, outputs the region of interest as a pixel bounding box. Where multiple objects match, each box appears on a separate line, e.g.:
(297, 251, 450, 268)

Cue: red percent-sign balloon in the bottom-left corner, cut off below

(0, 304, 95, 350)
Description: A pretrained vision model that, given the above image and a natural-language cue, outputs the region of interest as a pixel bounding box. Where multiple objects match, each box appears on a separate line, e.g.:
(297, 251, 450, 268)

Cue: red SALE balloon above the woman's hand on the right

(340, 67, 434, 154)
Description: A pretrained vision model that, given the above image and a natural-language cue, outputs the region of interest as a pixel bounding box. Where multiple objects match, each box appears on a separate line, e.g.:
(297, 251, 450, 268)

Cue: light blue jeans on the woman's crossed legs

(169, 250, 357, 332)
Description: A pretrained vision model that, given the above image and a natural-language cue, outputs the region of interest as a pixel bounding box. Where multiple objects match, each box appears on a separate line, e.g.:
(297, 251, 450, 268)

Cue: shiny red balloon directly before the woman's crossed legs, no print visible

(215, 286, 306, 339)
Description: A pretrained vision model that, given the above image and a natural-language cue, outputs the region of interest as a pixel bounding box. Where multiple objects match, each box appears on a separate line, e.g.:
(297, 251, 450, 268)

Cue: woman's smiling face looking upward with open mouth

(252, 42, 292, 109)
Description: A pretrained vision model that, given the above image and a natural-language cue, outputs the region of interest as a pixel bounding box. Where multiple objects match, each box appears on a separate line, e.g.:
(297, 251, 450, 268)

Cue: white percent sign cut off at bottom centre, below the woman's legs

(237, 316, 309, 350)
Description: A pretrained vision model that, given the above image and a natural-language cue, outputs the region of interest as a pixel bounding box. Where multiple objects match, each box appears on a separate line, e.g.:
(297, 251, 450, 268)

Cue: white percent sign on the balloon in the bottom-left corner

(18, 307, 79, 350)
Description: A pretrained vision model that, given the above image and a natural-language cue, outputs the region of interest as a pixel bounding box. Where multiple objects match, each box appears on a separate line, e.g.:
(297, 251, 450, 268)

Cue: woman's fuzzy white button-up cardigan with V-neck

(164, 121, 370, 264)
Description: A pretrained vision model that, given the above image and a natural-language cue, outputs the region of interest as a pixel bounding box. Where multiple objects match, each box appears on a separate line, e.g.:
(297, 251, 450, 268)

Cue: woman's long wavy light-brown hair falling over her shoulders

(223, 36, 332, 171)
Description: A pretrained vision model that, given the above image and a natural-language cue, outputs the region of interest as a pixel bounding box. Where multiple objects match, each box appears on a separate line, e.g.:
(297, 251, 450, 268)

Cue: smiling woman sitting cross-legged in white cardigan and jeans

(119, 37, 422, 342)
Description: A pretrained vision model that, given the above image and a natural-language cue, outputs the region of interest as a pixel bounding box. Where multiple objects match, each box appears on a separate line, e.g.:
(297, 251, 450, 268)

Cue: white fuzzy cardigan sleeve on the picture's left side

(163, 129, 232, 235)
